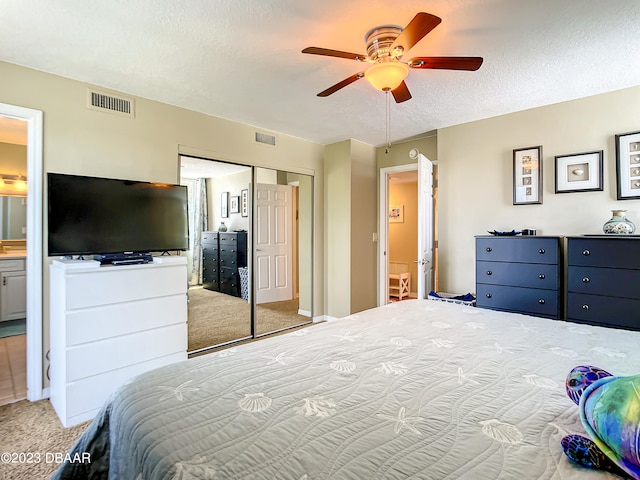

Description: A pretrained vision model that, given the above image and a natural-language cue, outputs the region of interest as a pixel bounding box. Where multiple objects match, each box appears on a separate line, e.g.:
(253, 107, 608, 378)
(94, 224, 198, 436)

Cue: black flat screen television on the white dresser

(47, 173, 189, 256)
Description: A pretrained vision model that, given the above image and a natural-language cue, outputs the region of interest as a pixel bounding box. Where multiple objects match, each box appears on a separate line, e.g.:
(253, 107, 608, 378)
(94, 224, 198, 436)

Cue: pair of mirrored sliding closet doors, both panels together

(181, 156, 313, 354)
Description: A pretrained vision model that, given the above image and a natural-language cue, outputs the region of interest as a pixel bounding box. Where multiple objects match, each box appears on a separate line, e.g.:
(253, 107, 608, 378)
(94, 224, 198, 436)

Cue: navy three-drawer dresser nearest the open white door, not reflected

(476, 236, 563, 318)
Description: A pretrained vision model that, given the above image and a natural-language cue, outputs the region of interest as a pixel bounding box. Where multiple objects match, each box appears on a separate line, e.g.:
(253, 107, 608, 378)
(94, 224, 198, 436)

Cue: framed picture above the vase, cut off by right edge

(616, 132, 640, 200)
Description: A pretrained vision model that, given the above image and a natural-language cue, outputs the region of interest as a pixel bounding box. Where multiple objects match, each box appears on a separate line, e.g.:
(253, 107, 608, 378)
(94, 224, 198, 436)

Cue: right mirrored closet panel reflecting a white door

(254, 168, 313, 336)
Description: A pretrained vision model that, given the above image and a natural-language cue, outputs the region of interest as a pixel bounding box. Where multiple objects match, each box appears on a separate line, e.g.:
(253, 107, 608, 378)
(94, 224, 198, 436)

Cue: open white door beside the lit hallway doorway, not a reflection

(416, 153, 433, 298)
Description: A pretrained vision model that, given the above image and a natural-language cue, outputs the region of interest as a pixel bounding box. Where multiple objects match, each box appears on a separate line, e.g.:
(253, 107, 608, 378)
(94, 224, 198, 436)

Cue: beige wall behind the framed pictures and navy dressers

(438, 87, 640, 293)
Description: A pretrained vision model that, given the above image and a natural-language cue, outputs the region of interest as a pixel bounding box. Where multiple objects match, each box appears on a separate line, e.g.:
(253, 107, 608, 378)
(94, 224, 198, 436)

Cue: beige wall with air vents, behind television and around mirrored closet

(0, 62, 325, 384)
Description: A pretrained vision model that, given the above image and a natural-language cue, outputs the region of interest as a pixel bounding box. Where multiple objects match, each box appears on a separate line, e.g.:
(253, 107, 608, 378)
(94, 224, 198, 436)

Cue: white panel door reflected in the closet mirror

(255, 183, 293, 303)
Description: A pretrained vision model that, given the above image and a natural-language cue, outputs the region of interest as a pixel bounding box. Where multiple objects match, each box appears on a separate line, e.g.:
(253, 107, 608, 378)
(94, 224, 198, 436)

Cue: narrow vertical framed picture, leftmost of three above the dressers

(513, 145, 542, 205)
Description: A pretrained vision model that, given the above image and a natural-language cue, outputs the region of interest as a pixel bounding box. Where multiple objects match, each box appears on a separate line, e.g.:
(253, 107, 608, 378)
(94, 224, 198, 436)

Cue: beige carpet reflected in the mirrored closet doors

(188, 287, 311, 352)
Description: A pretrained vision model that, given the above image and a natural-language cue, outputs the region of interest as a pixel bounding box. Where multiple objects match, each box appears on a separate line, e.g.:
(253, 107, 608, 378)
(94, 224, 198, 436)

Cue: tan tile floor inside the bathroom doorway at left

(0, 335, 27, 405)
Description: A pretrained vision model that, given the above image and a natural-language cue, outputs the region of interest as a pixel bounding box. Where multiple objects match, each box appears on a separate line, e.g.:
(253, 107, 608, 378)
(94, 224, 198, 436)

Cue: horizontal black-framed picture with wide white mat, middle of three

(555, 150, 603, 193)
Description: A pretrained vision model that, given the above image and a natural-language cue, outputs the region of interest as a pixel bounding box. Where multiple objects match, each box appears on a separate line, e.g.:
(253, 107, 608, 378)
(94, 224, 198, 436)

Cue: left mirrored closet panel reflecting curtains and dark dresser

(180, 156, 252, 353)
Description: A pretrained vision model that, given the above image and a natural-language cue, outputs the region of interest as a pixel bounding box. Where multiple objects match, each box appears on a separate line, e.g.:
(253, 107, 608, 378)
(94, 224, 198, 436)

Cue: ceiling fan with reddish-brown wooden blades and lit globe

(302, 12, 482, 103)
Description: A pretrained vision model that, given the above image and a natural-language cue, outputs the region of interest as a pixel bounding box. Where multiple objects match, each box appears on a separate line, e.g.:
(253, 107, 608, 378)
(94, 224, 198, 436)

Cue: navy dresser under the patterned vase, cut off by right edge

(567, 235, 640, 330)
